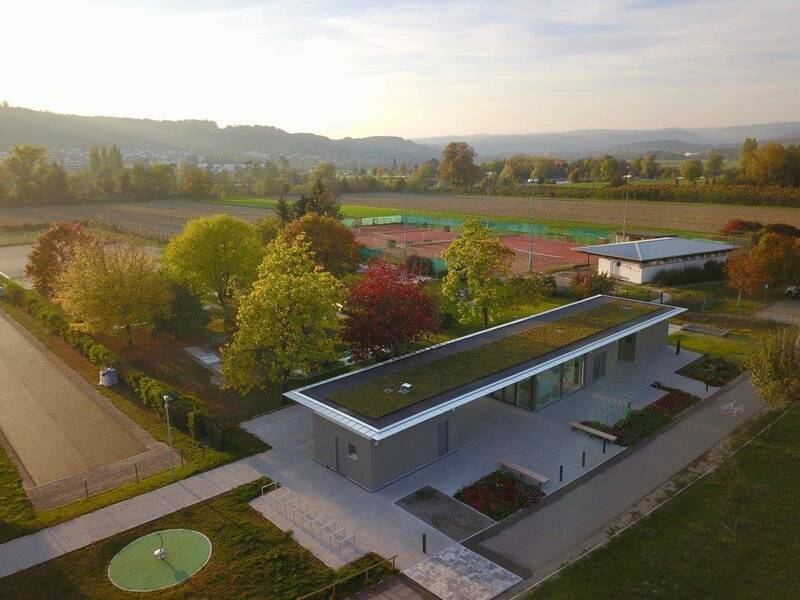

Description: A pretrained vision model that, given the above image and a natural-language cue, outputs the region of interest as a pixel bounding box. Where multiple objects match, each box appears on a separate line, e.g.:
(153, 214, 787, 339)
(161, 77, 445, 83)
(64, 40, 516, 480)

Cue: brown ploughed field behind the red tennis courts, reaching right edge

(342, 193, 800, 233)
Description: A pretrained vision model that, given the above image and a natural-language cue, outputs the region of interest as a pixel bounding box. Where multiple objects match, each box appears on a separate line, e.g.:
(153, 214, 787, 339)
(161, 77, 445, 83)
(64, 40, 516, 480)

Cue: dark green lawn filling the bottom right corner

(526, 407, 800, 600)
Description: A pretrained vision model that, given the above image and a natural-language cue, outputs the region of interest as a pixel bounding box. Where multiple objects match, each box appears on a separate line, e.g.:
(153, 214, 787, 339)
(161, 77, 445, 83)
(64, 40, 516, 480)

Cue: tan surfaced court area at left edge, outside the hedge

(0, 310, 169, 500)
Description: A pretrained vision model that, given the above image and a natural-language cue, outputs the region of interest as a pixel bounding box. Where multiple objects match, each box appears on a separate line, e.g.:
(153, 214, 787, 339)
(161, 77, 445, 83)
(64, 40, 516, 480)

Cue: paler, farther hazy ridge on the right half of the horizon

(414, 122, 800, 158)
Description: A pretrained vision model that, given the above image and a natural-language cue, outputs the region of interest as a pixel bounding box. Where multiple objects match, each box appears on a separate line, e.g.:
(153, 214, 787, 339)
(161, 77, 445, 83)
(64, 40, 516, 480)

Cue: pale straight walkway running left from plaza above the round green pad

(0, 459, 262, 577)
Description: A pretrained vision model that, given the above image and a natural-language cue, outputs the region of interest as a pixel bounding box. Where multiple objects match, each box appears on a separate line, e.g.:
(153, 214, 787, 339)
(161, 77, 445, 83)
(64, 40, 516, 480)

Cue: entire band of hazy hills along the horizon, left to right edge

(0, 105, 800, 165)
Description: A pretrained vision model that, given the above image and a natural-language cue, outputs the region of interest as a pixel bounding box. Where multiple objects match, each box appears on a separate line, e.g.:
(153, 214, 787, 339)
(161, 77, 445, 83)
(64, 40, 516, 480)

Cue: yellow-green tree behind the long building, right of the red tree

(442, 219, 514, 327)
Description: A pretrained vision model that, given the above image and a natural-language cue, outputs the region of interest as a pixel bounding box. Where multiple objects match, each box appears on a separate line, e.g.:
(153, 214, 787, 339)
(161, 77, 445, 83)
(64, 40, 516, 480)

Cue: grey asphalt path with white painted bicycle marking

(468, 378, 763, 580)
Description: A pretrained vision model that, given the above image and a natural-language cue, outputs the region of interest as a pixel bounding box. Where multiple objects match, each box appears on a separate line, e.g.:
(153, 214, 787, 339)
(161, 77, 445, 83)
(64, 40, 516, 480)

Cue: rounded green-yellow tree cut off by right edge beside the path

(747, 328, 800, 406)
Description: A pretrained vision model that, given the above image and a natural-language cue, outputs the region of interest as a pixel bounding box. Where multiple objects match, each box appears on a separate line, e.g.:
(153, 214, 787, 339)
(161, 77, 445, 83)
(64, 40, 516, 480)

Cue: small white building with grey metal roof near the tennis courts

(576, 237, 736, 283)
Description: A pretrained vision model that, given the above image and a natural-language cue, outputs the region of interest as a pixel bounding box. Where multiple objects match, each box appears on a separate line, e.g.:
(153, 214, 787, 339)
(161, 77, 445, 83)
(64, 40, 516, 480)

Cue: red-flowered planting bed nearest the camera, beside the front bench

(455, 469, 544, 521)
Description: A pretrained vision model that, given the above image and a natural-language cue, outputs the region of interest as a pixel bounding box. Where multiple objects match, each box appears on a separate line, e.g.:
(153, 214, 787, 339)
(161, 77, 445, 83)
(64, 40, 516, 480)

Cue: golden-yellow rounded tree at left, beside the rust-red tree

(55, 244, 172, 346)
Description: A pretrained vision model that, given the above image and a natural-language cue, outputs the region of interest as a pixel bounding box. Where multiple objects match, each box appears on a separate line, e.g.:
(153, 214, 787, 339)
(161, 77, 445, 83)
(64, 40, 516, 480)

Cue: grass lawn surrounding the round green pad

(2, 480, 388, 600)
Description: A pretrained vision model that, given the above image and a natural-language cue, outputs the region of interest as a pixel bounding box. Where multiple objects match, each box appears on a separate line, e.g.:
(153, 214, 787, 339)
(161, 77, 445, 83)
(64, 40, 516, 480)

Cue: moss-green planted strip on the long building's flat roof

(331, 300, 658, 419)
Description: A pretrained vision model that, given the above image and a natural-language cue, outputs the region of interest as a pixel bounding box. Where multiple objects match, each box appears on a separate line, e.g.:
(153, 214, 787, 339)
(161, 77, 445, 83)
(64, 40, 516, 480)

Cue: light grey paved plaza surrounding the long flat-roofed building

(243, 349, 714, 569)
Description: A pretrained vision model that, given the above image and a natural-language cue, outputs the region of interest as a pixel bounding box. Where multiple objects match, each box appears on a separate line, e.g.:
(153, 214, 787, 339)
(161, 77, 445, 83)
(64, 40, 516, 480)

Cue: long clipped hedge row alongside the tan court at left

(0, 277, 221, 445)
